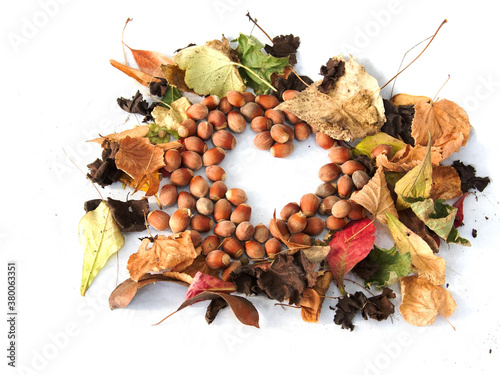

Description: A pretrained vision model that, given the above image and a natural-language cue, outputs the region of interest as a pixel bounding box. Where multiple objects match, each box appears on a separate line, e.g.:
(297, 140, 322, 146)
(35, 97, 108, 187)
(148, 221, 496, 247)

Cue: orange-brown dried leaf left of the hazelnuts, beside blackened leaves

(115, 136, 165, 196)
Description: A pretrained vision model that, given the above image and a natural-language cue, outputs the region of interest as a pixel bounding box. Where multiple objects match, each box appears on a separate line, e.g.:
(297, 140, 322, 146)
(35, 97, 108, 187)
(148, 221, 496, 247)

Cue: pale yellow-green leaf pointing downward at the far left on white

(78, 201, 125, 296)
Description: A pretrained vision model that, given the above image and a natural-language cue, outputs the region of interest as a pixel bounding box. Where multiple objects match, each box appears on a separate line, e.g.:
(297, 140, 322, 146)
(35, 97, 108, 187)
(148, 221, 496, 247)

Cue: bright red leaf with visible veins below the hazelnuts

(327, 218, 375, 295)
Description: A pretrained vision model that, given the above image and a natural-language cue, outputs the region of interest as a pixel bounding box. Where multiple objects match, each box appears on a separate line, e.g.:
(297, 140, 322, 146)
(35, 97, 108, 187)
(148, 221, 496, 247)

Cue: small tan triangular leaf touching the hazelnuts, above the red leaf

(352, 168, 398, 224)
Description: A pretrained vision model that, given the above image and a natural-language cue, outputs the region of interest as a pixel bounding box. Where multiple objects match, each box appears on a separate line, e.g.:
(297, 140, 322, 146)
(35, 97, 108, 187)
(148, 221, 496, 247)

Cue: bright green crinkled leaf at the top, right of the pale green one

(235, 34, 290, 95)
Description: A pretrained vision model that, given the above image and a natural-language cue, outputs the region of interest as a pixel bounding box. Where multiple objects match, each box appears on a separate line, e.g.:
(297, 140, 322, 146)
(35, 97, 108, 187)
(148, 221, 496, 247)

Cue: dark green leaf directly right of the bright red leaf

(366, 246, 412, 288)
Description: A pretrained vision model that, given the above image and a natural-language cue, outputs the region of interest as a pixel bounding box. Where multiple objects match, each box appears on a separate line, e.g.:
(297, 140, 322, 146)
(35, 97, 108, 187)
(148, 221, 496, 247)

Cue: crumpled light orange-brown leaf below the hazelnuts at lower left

(127, 231, 199, 281)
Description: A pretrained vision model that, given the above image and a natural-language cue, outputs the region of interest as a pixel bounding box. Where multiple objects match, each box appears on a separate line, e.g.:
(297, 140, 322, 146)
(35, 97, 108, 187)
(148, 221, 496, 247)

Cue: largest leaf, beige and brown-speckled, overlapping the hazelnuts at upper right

(276, 56, 385, 141)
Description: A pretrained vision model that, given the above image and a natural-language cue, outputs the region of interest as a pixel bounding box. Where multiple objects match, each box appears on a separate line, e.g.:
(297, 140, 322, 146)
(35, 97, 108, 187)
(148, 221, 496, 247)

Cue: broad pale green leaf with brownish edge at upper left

(174, 38, 246, 98)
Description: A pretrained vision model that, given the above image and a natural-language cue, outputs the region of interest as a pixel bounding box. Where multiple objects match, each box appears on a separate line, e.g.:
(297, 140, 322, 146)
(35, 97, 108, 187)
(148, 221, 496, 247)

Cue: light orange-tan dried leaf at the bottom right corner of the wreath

(399, 276, 457, 327)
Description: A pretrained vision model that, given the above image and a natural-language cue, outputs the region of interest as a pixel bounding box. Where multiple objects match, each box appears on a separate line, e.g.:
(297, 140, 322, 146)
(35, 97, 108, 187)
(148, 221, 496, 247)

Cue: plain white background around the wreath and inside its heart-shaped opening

(0, 0, 500, 375)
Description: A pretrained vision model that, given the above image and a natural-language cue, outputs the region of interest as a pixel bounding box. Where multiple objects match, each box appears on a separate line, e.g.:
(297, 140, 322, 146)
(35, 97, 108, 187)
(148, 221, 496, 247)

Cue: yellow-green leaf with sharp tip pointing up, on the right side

(394, 141, 432, 210)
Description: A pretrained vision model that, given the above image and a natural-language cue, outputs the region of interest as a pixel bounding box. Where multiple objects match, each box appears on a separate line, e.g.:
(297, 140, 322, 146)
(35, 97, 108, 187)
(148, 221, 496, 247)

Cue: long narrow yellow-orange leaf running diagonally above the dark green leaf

(386, 213, 446, 285)
